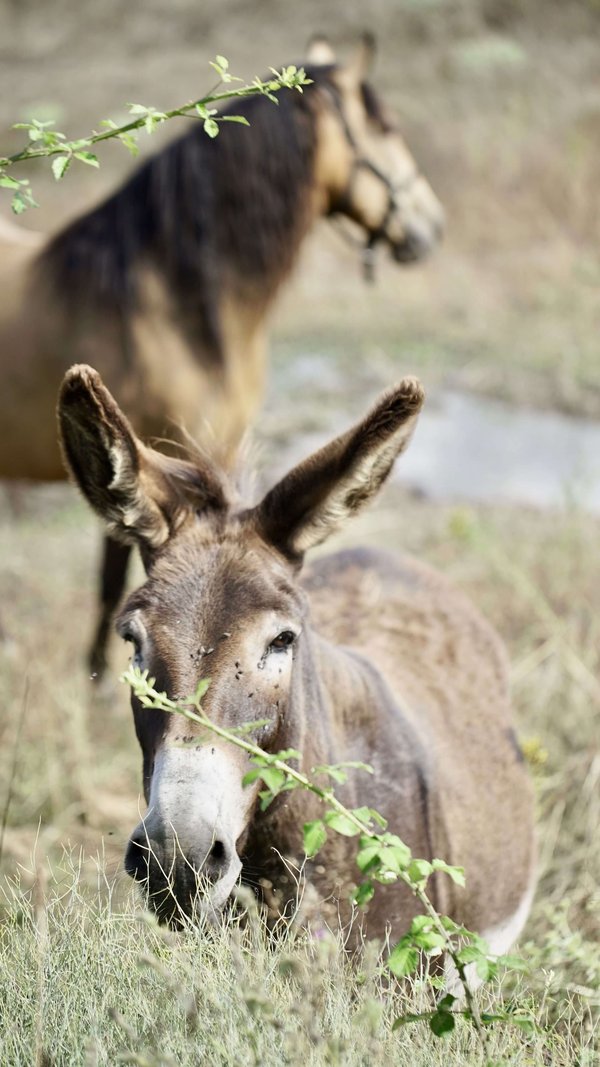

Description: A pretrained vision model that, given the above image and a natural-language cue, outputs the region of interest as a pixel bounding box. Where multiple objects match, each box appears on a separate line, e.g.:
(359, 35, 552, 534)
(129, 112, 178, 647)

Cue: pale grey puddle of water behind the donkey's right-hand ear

(258, 354, 600, 514)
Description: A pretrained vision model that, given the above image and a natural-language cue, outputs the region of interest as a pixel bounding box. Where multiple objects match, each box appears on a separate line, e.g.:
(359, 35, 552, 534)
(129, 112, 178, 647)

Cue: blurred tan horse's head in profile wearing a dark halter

(306, 37, 444, 262)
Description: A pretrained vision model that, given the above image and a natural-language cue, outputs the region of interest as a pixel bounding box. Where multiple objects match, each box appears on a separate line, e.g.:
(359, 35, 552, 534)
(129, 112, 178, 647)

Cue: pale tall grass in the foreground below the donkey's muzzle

(0, 853, 594, 1067)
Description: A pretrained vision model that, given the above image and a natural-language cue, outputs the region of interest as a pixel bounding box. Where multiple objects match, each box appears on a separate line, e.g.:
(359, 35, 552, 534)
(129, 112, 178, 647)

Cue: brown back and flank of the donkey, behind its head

(304, 548, 534, 952)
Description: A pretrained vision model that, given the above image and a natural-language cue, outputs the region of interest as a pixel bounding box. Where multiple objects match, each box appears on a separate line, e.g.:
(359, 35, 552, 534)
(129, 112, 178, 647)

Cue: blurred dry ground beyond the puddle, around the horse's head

(0, 0, 600, 415)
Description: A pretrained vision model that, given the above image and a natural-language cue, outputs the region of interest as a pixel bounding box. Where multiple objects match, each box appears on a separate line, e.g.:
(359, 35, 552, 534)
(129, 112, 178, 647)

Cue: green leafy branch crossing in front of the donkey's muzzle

(122, 667, 533, 1051)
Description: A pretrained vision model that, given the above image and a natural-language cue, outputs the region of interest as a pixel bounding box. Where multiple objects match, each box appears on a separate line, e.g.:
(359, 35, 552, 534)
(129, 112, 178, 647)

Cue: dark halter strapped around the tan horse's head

(321, 84, 416, 282)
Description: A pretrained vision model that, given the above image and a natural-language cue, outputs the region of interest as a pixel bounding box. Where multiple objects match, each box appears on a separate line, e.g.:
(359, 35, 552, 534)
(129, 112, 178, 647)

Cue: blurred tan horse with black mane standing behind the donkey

(0, 41, 443, 678)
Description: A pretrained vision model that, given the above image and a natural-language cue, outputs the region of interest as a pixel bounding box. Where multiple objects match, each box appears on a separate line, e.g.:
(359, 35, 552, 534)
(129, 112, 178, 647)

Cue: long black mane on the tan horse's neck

(37, 67, 332, 361)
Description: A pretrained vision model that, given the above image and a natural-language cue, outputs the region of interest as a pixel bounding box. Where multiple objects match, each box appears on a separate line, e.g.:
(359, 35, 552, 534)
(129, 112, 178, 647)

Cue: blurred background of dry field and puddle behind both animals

(0, 0, 600, 1015)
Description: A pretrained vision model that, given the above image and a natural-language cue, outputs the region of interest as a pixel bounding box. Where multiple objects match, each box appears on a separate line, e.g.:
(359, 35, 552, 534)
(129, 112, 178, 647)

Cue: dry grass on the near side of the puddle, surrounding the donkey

(0, 490, 600, 1065)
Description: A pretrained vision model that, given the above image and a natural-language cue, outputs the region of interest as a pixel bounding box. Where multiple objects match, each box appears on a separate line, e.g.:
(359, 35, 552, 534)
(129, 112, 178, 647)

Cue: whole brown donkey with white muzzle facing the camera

(59, 366, 535, 953)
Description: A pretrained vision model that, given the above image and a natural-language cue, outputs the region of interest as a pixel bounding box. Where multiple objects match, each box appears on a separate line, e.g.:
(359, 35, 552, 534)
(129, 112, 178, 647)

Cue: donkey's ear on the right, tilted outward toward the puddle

(253, 378, 424, 559)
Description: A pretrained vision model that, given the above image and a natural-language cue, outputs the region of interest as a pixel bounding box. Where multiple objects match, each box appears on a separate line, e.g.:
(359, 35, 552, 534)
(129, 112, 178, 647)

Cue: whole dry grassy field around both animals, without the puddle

(0, 0, 600, 1067)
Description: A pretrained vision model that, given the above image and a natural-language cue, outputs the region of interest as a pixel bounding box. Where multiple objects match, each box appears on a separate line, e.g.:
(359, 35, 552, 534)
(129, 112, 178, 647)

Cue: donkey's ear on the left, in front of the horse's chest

(58, 365, 225, 548)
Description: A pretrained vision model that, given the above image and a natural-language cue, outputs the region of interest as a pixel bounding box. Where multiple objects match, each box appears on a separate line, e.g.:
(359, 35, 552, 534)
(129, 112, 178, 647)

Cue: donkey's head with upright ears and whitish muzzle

(54, 366, 423, 922)
